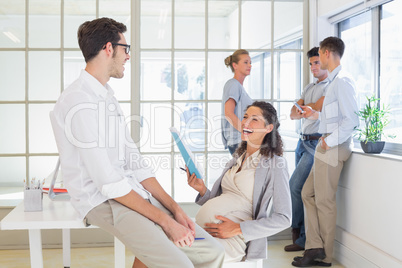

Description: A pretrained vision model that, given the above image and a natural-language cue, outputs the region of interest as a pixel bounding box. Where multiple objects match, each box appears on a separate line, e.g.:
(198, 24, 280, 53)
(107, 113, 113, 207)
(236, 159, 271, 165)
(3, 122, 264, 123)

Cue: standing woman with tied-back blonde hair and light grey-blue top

(221, 49, 253, 154)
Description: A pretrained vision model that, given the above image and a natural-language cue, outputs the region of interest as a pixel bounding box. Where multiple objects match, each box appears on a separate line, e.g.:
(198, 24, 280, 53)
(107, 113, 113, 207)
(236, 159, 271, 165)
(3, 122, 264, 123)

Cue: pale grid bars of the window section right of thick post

(137, 0, 309, 203)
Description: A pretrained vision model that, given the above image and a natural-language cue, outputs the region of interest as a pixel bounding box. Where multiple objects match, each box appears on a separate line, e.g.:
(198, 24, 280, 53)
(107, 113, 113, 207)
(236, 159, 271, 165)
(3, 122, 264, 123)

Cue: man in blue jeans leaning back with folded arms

(285, 47, 328, 251)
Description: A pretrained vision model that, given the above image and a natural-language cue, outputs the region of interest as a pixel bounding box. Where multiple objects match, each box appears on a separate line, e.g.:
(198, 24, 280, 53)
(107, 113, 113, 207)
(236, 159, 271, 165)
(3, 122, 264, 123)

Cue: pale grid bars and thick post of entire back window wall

(0, 0, 309, 197)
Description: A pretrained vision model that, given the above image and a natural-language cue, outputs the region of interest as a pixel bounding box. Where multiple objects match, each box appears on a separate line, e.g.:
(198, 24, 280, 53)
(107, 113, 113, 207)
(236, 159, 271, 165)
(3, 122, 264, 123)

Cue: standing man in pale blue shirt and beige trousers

(292, 37, 359, 267)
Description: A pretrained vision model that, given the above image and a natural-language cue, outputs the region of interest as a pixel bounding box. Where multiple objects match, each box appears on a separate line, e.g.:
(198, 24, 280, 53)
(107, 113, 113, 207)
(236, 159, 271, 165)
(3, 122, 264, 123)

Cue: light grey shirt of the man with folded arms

(300, 77, 329, 135)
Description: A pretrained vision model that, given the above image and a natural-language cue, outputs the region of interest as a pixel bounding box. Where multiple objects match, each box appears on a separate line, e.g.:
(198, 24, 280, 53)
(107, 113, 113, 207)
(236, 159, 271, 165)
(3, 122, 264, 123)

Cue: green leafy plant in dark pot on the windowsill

(354, 96, 395, 154)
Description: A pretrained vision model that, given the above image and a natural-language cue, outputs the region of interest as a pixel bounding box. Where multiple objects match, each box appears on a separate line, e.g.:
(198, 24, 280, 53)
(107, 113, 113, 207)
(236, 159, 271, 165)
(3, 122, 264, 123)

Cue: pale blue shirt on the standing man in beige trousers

(318, 65, 359, 147)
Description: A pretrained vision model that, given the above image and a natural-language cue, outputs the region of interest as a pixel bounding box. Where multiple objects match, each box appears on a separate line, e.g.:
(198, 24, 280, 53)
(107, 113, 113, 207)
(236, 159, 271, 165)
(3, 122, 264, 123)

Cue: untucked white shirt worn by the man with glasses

(52, 70, 154, 219)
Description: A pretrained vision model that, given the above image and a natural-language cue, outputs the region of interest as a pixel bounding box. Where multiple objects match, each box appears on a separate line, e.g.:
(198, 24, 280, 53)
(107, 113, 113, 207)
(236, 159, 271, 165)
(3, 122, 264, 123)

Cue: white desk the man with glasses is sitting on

(0, 195, 125, 268)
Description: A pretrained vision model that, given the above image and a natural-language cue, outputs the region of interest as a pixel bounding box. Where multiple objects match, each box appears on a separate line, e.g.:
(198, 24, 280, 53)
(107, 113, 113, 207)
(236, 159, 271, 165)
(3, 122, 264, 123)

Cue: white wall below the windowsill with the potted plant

(335, 152, 402, 268)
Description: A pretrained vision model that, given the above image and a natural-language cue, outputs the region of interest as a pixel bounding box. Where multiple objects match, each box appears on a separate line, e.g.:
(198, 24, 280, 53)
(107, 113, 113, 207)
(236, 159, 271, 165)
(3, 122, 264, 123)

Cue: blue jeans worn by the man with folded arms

(289, 134, 319, 248)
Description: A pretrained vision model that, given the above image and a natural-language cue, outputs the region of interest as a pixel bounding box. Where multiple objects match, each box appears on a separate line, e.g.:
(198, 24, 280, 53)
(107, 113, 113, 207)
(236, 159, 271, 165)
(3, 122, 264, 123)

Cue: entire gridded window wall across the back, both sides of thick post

(0, 0, 308, 202)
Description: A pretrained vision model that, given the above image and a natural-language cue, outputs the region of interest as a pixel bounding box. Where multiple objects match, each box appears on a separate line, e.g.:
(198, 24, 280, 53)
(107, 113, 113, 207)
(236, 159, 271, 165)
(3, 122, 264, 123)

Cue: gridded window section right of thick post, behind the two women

(139, 0, 303, 202)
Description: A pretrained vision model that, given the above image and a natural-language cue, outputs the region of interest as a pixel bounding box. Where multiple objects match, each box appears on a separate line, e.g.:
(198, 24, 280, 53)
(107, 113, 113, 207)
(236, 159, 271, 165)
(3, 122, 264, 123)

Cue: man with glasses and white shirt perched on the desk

(51, 18, 224, 268)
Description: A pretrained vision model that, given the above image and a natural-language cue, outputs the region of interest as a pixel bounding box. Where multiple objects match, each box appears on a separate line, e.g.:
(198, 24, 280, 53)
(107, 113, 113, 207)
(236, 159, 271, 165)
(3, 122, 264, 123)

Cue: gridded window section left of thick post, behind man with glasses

(0, 0, 131, 189)
